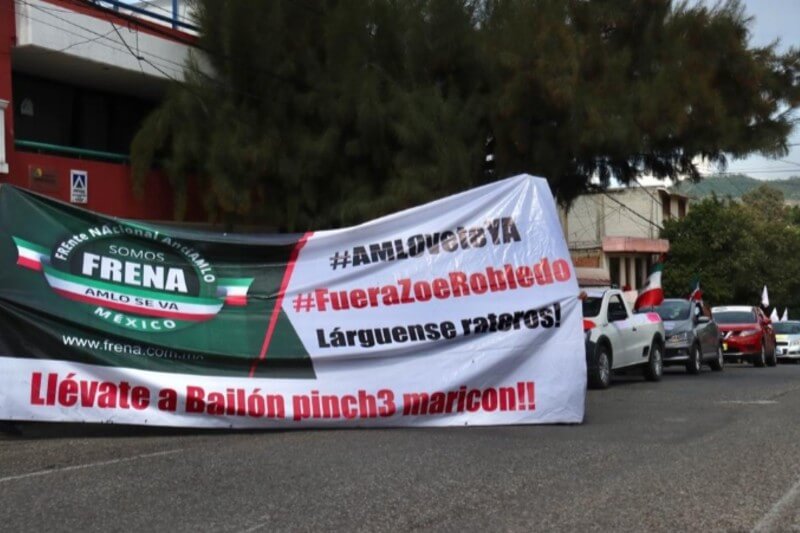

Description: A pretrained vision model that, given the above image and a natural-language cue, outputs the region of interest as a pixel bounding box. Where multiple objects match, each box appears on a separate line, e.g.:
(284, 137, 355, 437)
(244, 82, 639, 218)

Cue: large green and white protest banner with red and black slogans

(0, 176, 586, 428)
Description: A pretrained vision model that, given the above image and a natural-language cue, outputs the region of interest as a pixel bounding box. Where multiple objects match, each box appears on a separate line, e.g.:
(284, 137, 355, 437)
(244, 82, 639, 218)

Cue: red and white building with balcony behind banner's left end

(0, 0, 197, 220)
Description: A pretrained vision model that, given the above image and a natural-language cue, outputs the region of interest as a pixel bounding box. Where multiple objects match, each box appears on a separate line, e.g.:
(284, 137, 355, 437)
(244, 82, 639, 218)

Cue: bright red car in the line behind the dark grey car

(711, 305, 778, 366)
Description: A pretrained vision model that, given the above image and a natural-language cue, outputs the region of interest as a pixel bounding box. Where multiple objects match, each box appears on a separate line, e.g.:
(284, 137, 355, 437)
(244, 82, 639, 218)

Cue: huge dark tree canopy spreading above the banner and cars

(131, 0, 800, 230)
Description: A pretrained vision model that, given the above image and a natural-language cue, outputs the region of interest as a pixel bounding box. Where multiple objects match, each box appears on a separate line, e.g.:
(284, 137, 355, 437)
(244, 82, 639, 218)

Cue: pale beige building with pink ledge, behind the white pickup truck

(561, 187, 689, 291)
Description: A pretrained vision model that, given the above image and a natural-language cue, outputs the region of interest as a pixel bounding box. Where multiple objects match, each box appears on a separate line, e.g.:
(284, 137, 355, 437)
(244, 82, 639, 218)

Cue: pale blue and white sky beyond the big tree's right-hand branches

(727, 0, 800, 179)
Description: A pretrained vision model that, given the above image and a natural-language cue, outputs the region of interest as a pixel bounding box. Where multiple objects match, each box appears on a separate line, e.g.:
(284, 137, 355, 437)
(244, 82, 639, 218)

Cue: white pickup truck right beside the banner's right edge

(583, 289, 664, 389)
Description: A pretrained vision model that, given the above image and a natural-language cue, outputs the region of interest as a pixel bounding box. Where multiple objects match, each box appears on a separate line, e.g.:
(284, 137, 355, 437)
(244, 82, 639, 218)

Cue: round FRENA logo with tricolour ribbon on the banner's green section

(14, 224, 253, 332)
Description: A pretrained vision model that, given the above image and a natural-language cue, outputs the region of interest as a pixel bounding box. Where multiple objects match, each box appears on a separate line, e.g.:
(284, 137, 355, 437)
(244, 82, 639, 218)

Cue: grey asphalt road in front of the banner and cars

(0, 365, 800, 531)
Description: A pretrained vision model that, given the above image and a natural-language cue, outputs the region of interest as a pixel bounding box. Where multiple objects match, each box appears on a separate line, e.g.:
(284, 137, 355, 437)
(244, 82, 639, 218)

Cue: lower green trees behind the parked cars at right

(662, 192, 800, 307)
